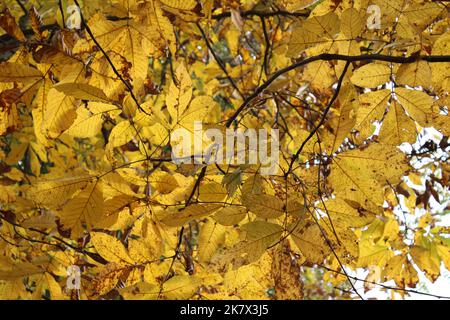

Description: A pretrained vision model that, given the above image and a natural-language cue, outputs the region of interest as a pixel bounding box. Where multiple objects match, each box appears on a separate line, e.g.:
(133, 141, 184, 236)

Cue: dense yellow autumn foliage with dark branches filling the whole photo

(0, 0, 450, 299)
